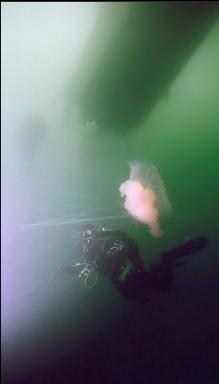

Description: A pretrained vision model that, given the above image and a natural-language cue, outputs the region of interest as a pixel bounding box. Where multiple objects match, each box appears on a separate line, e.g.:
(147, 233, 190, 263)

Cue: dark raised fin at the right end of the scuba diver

(161, 236, 208, 261)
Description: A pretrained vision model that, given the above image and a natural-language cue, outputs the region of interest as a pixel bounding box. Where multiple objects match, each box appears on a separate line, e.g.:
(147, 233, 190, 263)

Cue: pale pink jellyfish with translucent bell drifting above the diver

(119, 161, 171, 238)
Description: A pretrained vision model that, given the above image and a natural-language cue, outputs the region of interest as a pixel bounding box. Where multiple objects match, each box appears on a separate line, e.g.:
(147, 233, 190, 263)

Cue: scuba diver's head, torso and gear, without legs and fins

(62, 225, 144, 283)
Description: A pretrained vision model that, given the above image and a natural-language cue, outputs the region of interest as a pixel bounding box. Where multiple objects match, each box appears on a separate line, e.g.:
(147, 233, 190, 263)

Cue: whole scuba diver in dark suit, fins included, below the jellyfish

(62, 225, 208, 302)
